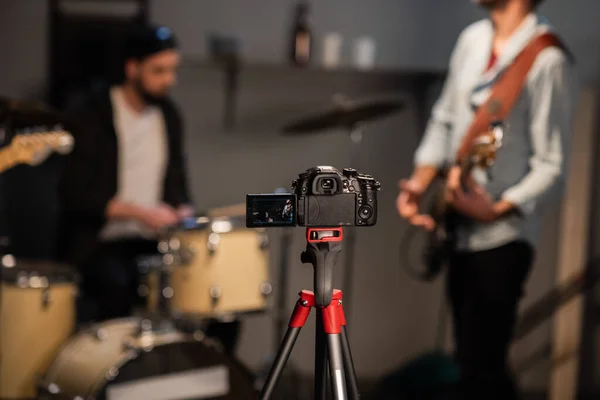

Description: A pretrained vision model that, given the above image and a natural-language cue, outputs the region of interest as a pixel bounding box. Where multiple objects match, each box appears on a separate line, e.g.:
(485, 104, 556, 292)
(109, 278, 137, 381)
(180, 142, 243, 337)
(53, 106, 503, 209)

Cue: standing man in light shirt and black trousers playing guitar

(397, 0, 574, 400)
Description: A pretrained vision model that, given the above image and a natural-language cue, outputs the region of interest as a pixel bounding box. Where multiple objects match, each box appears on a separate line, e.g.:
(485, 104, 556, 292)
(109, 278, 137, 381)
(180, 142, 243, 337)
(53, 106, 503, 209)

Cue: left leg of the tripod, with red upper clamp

(259, 290, 315, 400)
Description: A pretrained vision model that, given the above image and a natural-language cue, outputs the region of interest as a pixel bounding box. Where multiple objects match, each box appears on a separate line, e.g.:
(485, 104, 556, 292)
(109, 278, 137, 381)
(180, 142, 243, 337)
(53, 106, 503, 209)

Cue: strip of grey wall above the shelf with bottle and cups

(151, 0, 600, 81)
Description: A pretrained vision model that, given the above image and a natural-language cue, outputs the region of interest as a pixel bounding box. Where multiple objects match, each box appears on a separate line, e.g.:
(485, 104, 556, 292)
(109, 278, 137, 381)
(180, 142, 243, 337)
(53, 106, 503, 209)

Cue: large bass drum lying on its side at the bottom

(40, 318, 257, 400)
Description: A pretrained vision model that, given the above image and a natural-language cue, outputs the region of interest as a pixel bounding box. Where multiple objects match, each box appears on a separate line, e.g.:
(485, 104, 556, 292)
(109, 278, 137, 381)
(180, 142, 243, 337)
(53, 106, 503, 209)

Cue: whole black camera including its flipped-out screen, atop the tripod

(246, 166, 381, 228)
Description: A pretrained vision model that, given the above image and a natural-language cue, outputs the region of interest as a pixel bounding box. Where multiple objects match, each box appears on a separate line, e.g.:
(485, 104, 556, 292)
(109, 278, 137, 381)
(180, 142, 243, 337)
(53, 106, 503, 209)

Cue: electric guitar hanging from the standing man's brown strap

(400, 122, 504, 281)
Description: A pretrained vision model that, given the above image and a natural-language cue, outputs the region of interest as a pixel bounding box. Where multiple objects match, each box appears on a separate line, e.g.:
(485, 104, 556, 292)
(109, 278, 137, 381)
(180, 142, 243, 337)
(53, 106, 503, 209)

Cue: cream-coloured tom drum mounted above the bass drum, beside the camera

(164, 217, 272, 319)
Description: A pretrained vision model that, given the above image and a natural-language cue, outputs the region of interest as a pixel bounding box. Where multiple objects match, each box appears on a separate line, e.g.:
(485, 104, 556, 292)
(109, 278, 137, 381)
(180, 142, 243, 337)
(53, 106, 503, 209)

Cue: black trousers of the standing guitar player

(447, 241, 534, 400)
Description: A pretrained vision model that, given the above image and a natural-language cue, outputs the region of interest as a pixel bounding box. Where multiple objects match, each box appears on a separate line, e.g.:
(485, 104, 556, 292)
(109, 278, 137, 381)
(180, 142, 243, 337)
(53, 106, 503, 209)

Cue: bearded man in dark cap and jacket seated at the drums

(61, 26, 239, 350)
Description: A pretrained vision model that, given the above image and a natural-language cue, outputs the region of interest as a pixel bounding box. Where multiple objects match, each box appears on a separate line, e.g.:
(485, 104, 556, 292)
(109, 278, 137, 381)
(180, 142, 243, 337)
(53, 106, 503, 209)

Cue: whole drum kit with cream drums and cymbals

(0, 94, 402, 400)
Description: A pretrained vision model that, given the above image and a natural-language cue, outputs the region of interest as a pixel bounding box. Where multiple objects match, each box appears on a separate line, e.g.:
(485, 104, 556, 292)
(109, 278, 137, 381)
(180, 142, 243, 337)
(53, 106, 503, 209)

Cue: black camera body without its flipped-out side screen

(292, 166, 381, 227)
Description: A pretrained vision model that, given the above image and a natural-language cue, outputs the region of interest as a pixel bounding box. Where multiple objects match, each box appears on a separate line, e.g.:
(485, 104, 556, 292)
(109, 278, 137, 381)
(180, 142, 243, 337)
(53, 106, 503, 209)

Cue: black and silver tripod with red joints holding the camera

(260, 227, 360, 400)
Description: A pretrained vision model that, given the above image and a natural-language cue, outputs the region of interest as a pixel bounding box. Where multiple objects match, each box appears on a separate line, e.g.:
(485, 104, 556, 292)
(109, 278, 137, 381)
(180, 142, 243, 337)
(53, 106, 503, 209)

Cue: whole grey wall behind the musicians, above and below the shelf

(0, 0, 600, 396)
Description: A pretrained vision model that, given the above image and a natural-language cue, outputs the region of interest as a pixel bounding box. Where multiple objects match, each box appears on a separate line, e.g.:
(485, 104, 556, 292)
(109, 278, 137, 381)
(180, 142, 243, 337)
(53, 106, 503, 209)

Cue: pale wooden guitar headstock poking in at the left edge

(0, 130, 74, 173)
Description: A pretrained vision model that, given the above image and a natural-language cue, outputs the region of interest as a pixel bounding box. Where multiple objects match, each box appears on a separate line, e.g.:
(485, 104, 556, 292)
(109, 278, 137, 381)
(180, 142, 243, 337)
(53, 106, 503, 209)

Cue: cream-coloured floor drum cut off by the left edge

(0, 255, 77, 399)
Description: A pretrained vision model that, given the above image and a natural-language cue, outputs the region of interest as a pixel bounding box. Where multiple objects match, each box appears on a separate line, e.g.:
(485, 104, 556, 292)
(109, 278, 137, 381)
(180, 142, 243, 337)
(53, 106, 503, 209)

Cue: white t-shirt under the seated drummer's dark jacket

(100, 87, 168, 240)
